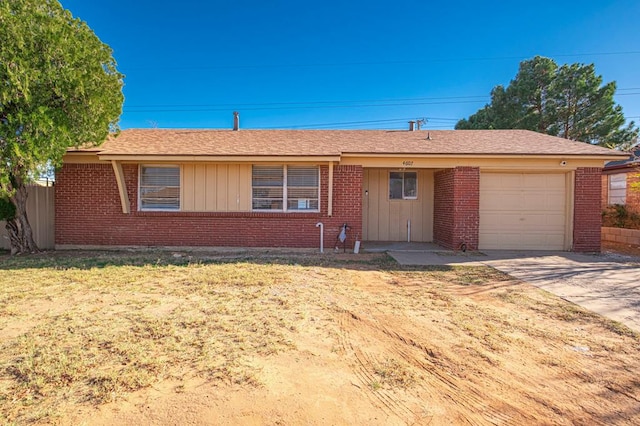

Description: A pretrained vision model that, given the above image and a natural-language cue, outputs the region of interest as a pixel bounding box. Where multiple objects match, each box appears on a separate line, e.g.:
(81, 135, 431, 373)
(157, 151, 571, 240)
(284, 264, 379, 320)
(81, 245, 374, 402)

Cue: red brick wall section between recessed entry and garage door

(433, 167, 480, 250)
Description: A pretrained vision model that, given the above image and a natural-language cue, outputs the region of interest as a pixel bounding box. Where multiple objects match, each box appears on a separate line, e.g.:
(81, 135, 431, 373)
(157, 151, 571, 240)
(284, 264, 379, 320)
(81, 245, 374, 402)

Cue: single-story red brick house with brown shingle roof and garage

(55, 129, 620, 251)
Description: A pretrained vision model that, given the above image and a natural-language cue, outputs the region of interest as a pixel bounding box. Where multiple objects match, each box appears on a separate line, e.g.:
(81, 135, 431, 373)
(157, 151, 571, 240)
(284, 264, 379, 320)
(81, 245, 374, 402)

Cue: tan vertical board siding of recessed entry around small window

(362, 169, 434, 242)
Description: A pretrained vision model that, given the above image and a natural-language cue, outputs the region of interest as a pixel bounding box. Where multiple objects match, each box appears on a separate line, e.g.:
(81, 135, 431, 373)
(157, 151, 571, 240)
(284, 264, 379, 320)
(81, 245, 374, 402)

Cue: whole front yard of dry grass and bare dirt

(0, 253, 640, 426)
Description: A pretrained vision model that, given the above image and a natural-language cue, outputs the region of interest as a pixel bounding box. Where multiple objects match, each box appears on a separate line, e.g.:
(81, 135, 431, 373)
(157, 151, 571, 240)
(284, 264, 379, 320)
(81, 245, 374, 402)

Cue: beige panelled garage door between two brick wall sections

(479, 173, 567, 250)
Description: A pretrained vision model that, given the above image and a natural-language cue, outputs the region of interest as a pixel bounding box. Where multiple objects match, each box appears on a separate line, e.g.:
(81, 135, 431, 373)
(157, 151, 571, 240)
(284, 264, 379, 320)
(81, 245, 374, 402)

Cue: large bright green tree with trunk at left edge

(0, 0, 124, 253)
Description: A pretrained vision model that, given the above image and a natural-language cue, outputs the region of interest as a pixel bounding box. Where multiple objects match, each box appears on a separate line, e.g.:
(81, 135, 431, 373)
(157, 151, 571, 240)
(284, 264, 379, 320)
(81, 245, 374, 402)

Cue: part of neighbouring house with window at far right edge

(602, 145, 640, 213)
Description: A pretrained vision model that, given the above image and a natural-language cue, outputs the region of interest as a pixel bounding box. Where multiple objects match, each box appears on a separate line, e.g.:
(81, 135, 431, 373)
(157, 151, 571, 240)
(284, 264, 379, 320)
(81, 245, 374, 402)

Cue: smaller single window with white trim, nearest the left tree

(139, 165, 180, 211)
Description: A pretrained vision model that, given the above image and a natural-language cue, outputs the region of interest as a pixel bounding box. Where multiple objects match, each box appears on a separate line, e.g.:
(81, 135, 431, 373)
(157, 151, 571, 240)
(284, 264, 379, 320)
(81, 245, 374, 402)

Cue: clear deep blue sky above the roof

(61, 0, 640, 129)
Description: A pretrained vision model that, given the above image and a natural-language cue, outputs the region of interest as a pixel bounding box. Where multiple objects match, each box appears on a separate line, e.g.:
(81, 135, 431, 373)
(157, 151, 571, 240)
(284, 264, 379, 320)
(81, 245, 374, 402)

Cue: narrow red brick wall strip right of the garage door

(573, 167, 602, 252)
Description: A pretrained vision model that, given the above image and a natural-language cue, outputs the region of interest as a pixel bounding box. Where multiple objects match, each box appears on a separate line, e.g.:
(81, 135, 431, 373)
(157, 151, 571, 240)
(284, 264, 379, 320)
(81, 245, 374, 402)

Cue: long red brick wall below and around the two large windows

(55, 164, 363, 248)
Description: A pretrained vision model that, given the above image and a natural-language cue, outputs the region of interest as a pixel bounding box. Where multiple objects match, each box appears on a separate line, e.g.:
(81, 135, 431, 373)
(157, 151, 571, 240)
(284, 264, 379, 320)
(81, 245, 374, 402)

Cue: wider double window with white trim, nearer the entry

(251, 166, 320, 212)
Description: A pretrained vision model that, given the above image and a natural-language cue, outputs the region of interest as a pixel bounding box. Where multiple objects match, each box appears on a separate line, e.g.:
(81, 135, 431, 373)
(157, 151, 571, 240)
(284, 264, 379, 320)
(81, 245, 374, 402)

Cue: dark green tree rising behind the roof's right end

(456, 56, 638, 147)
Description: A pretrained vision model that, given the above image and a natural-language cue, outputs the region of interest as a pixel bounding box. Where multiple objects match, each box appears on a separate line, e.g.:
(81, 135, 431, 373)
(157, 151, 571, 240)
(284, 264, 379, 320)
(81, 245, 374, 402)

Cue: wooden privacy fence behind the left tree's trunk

(0, 185, 55, 250)
